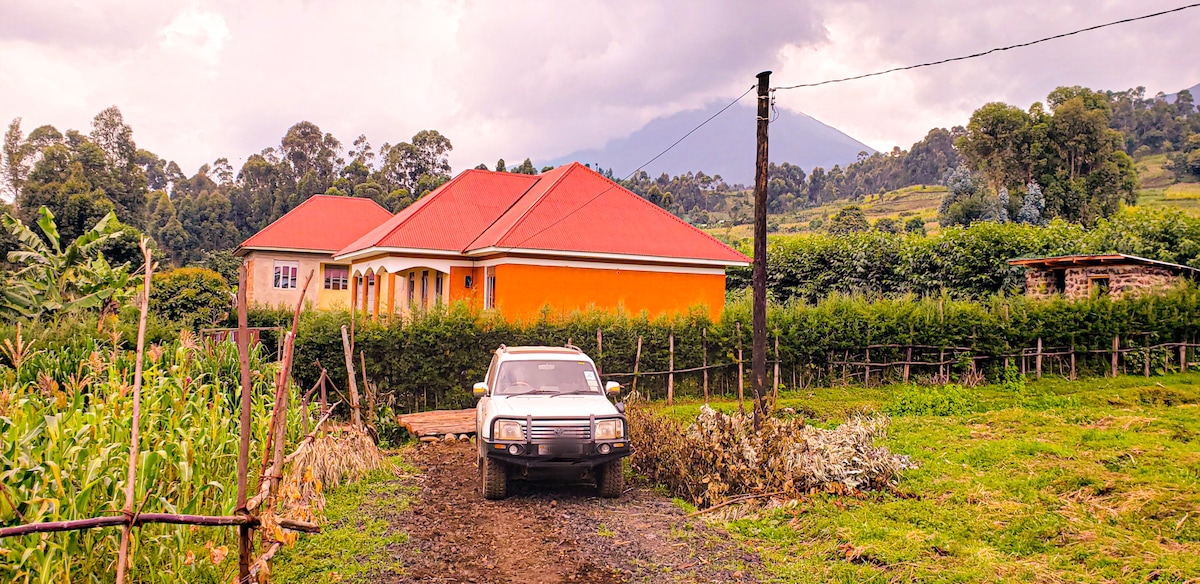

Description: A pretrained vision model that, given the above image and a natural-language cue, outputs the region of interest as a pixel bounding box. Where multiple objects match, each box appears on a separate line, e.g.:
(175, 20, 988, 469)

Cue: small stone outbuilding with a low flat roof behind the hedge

(1008, 253, 1200, 300)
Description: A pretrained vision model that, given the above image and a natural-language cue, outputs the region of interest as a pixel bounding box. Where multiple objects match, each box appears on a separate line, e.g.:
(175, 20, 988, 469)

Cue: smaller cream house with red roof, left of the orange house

(234, 194, 391, 309)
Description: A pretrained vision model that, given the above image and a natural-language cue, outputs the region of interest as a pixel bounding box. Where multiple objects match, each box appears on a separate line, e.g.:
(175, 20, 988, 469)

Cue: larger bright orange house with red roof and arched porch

(235, 163, 750, 319)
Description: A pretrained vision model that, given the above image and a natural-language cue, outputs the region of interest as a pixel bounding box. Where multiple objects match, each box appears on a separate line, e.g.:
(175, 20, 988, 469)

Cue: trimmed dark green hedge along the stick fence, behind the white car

(281, 287, 1200, 411)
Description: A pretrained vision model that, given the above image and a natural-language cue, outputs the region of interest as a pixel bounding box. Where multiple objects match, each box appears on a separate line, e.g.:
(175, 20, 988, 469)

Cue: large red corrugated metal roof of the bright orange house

(338, 162, 749, 264)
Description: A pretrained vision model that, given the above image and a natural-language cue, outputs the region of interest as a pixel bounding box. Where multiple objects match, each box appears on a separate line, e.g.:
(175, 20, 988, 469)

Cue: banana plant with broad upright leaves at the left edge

(0, 206, 130, 319)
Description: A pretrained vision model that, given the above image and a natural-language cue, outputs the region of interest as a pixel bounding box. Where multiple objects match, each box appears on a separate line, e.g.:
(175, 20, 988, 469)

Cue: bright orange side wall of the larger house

(492, 264, 725, 320)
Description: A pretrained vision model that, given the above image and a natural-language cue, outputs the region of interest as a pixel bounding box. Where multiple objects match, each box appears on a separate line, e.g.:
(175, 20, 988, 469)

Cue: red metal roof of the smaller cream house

(239, 194, 391, 252)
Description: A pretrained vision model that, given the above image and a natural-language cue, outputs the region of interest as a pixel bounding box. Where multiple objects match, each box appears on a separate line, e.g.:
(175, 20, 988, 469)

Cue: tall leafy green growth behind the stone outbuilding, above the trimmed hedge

(728, 207, 1200, 302)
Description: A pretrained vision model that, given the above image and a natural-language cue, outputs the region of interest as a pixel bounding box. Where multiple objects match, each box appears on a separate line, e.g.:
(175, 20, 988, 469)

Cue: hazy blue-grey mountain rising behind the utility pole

(538, 104, 875, 186)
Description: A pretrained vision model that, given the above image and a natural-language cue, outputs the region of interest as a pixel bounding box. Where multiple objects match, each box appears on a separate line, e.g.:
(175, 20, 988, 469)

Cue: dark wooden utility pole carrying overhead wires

(750, 71, 770, 429)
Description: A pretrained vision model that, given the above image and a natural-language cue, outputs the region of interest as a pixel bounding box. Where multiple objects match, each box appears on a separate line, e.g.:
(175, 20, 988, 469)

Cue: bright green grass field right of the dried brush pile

(662, 373, 1200, 583)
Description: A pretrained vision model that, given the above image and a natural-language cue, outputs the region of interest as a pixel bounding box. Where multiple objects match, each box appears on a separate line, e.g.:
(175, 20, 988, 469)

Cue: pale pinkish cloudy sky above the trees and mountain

(0, 0, 1200, 173)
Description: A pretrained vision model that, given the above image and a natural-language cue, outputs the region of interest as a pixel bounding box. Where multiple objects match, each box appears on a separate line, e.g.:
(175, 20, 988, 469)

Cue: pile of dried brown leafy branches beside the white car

(629, 405, 917, 506)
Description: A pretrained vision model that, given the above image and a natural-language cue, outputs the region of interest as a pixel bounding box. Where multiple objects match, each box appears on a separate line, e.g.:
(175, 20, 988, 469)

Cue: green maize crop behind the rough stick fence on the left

(0, 336, 299, 583)
